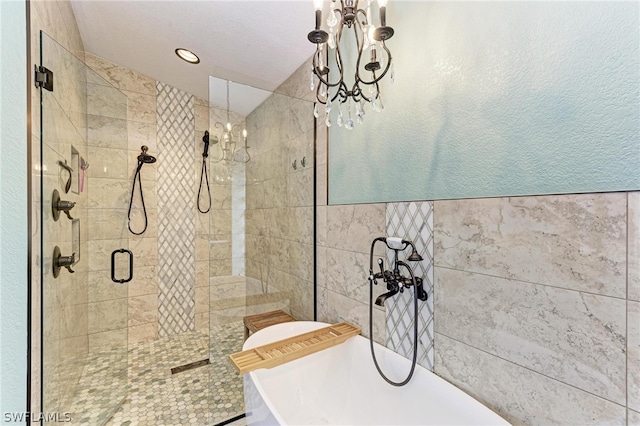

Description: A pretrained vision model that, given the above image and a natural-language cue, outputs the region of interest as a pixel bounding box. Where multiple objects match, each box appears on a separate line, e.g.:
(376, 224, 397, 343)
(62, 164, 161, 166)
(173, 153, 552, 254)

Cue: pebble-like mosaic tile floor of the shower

(72, 321, 244, 426)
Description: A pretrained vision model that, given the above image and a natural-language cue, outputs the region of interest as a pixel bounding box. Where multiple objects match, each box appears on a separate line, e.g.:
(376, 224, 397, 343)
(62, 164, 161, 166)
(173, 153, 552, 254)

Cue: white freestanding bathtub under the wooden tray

(243, 321, 509, 425)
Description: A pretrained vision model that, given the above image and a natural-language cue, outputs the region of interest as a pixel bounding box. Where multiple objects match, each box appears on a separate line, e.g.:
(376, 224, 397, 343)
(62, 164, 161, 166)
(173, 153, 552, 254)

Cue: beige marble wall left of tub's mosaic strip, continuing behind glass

(262, 60, 386, 343)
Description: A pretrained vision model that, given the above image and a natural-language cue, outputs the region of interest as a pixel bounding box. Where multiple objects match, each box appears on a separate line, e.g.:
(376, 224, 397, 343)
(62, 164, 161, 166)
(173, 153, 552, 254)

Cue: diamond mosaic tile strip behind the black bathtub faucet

(385, 201, 433, 371)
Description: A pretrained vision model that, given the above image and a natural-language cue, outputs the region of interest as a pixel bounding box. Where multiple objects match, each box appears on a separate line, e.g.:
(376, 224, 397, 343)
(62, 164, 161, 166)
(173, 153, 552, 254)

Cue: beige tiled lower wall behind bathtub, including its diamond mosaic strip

(318, 192, 640, 424)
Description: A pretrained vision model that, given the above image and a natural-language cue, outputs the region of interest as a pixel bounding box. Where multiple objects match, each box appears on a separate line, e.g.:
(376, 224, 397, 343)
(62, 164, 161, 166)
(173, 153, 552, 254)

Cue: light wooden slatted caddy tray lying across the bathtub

(229, 322, 361, 374)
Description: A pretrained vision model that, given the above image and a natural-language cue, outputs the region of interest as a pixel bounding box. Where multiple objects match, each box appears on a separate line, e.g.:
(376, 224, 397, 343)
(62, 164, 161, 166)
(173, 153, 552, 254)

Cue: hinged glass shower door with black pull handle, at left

(40, 33, 129, 425)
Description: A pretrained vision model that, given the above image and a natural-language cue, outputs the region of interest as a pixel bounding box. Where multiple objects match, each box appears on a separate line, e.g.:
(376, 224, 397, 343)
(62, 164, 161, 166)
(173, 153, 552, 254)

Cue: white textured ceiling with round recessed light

(71, 0, 314, 113)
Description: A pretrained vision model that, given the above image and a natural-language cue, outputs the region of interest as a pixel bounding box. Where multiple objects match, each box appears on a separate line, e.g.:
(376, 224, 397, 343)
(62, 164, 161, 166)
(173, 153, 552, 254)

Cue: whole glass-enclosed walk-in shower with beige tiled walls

(32, 34, 315, 425)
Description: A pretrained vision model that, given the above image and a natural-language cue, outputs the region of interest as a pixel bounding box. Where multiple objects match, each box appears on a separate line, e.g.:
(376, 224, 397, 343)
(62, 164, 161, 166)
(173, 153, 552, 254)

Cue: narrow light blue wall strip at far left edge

(0, 0, 28, 424)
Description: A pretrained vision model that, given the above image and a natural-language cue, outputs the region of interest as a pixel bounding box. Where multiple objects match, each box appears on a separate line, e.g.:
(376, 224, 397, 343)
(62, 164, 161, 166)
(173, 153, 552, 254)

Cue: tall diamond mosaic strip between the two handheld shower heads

(156, 82, 196, 336)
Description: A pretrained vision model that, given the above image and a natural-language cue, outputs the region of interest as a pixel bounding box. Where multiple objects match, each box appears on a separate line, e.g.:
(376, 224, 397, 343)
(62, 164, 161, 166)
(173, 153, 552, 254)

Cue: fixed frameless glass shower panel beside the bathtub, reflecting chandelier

(209, 77, 315, 424)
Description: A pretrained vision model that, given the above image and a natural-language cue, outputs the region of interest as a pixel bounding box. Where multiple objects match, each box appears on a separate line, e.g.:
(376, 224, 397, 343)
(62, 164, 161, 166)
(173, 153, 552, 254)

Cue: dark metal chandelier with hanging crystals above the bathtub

(307, 0, 394, 130)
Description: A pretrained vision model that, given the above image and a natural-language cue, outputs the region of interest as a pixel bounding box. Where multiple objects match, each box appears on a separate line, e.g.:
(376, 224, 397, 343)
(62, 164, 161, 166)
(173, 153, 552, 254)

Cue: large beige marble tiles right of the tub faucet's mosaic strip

(434, 193, 640, 424)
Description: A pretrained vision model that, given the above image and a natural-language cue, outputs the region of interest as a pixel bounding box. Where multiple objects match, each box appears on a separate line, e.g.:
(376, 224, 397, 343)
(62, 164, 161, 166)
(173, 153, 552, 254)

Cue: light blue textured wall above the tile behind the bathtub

(329, 0, 640, 204)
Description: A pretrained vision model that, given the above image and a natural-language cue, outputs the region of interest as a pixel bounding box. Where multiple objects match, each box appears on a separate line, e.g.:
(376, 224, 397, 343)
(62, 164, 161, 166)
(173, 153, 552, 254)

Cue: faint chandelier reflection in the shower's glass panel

(211, 80, 251, 172)
